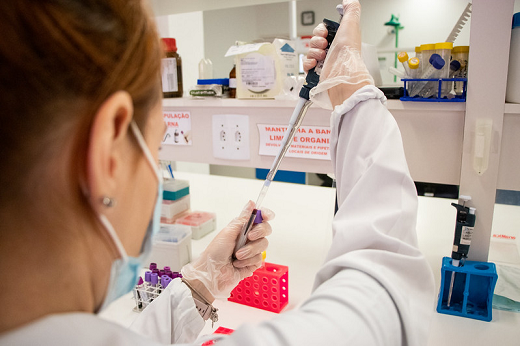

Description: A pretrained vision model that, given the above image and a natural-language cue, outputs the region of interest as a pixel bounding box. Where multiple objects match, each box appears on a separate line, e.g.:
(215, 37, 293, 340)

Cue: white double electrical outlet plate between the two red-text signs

(213, 114, 250, 160)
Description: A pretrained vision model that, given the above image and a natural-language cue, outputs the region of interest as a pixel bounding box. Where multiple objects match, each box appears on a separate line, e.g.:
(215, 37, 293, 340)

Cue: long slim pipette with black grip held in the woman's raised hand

(233, 5, 343, 258)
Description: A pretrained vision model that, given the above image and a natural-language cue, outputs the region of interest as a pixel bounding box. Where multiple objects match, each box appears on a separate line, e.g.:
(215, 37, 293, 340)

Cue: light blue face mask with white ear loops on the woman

(98, 121, 163, 312)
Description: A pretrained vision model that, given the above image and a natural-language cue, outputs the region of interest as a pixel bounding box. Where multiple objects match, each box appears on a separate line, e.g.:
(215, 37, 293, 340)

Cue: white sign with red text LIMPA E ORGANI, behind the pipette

(258, 124, 330, 160)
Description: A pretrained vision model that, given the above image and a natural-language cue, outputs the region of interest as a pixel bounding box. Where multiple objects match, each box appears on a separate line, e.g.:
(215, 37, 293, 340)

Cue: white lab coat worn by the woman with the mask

(0, 86, 435, 346)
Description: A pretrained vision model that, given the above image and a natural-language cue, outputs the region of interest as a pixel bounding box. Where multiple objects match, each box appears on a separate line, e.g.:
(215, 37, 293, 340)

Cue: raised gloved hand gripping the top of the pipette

(303, 0, 374, 109)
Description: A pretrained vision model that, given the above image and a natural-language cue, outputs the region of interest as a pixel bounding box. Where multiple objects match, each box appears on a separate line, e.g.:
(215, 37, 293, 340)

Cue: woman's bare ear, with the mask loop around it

(86, 91, 134, 209)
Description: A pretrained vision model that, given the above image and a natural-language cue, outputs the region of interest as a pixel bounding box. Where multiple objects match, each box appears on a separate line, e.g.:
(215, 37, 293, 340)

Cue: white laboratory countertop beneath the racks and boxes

(101, 173, 520, 346)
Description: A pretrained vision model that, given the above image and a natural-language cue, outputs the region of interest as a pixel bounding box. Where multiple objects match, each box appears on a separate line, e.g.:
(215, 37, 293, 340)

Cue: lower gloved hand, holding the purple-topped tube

(181, 201, 274, 301)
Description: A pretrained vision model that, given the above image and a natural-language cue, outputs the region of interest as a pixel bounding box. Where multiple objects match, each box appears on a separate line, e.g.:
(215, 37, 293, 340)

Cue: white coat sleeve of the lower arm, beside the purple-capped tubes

(130, 279, 205, 345)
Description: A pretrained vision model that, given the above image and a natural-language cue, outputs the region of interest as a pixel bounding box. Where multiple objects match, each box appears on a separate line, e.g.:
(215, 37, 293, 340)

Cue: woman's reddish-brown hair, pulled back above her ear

(0, 0, 162, 206)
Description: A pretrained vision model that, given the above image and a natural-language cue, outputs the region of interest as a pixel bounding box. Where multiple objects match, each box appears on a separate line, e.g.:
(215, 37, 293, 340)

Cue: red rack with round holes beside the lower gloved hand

(228, 262, 289, 313)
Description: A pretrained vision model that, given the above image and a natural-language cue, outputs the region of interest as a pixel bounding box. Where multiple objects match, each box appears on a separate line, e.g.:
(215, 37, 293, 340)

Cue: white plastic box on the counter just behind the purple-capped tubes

(149, 224, 191, 272)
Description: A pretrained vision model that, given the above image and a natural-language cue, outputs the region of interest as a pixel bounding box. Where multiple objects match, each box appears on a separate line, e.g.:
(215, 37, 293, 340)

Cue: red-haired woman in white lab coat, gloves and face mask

(0, 0, 433, 345)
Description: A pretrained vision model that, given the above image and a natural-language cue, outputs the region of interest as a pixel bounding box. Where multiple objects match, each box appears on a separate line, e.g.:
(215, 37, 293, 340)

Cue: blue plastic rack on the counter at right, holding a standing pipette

(437, 257, 498, 322)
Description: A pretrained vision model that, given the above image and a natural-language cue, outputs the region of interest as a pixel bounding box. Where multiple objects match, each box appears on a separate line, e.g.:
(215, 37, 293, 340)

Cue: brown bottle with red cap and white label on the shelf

(161, 38, 183, 98)
